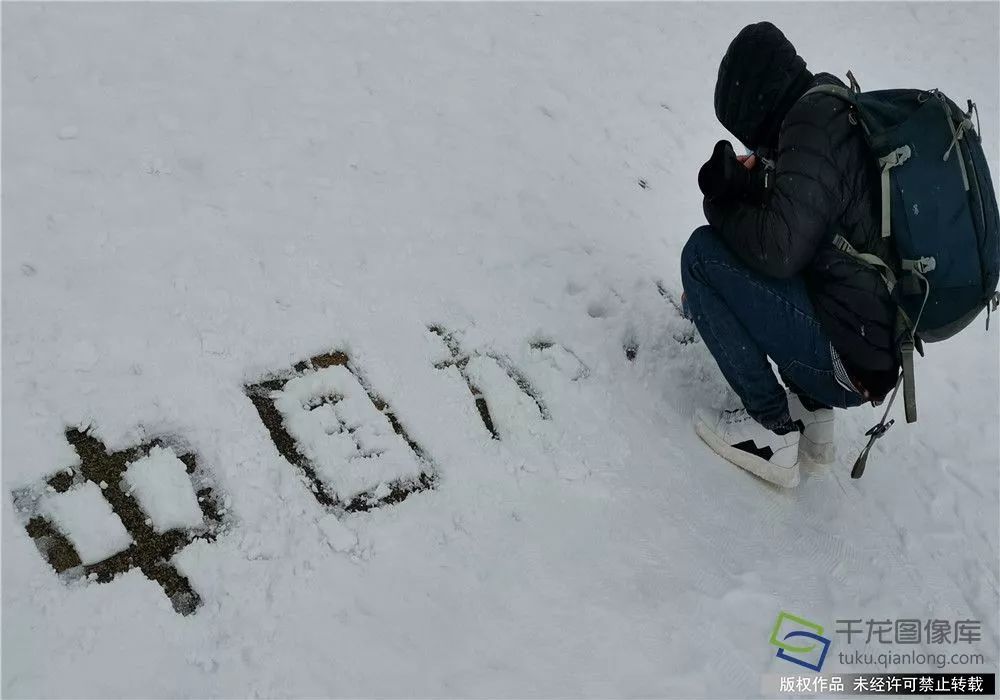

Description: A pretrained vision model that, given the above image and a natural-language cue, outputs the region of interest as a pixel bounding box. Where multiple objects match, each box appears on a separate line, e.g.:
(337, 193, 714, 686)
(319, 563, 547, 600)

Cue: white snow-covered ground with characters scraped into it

(2, 3, 1000, 697)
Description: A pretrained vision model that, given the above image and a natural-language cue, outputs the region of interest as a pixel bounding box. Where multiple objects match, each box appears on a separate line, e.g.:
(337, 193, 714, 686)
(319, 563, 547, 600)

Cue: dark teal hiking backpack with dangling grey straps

(806, 72, 1000, 479)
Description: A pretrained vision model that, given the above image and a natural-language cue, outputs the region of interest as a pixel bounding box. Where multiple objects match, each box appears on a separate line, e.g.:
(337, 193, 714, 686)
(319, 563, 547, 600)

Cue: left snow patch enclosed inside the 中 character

(39, 482, 132, 564)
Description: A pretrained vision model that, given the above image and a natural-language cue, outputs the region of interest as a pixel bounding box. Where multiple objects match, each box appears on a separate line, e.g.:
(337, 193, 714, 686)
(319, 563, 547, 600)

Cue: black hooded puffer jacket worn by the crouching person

(704, 22, 898, 399)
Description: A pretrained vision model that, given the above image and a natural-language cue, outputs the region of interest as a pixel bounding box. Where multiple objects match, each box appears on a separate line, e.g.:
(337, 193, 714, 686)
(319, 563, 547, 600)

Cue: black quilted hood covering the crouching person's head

(715, 22, 813, 149)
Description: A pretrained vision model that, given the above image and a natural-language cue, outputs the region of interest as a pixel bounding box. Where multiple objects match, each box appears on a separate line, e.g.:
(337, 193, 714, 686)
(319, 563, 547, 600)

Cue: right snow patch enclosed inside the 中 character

(125, 446, 204, 532)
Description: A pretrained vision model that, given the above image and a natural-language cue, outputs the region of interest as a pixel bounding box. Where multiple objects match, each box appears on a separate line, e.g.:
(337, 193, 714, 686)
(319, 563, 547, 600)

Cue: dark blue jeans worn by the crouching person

(681, 226, 864, 428)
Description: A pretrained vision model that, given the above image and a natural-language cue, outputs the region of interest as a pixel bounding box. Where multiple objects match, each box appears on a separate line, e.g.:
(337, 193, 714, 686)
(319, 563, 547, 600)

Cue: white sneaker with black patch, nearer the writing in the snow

(694, 408, 799, 488)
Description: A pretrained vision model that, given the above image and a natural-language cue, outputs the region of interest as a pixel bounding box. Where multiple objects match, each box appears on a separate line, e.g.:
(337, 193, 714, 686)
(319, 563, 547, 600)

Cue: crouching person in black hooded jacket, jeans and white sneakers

(681, 22, 898, 487)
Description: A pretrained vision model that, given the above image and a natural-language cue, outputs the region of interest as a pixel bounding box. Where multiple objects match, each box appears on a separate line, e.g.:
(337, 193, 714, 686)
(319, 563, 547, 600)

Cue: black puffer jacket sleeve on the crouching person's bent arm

(704, 95, 846, 277)
